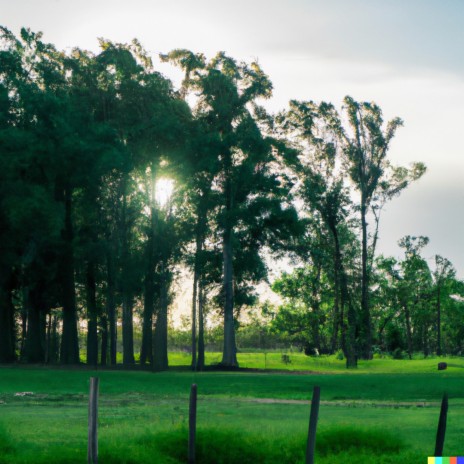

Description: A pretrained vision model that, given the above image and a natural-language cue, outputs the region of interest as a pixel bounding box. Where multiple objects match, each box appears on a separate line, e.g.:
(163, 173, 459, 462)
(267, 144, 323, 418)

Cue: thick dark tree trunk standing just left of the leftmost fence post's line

(57, 185, 80, 364)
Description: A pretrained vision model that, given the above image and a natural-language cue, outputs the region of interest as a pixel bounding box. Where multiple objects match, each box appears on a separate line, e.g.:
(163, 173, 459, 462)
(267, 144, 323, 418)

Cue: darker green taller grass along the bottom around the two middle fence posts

(101, 428, 407, 464)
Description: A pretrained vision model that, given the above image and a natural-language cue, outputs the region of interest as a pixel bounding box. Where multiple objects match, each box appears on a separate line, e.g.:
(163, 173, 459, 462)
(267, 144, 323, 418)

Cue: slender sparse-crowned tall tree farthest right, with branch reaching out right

(290, 96, 425, 358)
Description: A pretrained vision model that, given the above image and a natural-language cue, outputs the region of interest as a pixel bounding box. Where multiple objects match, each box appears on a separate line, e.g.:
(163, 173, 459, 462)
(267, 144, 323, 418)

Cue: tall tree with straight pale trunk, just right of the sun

(167, 50, 300, 367)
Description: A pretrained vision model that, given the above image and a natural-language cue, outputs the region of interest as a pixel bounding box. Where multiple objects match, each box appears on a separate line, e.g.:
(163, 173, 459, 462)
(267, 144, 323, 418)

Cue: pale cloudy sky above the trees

(0, 0, 464, 278)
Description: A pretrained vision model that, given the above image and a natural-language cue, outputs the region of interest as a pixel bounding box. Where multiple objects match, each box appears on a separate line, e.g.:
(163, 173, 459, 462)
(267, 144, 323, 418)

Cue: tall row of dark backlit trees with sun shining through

(0, 28, 460, 370)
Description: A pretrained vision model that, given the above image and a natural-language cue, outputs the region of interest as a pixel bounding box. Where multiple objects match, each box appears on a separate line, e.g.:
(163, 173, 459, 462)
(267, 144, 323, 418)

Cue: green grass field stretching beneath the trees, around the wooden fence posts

(0, 353, 464, 464)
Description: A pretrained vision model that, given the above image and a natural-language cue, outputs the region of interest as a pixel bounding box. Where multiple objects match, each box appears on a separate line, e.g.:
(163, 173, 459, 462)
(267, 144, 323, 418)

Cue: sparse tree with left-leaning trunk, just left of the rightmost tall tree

(278, 101, 357, 367)
